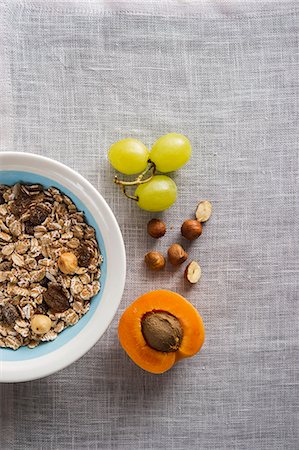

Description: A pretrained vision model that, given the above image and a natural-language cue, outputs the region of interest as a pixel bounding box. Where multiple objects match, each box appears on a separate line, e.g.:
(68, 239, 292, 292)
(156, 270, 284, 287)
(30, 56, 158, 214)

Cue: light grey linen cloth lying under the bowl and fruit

(0, 0, 299, 450)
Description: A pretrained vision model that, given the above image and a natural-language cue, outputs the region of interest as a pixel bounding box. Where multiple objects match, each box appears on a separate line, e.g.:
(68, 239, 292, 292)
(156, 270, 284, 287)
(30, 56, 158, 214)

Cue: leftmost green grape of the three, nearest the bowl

(108, 138, 149, 175)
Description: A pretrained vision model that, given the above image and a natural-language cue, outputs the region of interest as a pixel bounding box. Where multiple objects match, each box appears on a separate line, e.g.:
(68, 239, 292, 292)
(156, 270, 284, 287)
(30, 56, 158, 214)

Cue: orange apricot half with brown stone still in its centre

(118, 290, 205, 374)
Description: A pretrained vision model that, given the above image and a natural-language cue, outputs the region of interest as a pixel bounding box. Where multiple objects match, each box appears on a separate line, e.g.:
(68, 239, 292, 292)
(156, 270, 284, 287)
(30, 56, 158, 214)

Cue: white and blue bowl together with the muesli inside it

(0, 152, 126, 382)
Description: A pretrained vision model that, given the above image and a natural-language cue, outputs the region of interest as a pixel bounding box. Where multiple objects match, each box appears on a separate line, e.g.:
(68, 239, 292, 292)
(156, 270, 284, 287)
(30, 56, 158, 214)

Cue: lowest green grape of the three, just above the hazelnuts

(135, 175, 177, 211)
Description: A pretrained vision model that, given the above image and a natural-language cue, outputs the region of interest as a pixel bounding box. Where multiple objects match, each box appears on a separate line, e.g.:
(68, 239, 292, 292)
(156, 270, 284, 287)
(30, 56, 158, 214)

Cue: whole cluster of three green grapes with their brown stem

(108, 133, 191, 211)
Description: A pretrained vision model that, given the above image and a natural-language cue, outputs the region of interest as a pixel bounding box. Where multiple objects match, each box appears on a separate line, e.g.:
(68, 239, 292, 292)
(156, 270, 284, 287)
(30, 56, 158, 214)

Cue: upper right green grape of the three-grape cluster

(150, 133, 191, 173)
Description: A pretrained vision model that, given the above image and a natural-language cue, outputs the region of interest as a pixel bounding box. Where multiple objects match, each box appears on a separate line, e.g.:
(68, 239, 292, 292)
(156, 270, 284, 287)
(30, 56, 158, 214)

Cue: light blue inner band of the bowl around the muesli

(0, 170, 107, 361)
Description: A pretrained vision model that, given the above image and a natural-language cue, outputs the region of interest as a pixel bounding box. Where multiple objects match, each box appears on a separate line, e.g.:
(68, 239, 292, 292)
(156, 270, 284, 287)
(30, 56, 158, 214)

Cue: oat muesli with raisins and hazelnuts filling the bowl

(0, 183, 103, 350)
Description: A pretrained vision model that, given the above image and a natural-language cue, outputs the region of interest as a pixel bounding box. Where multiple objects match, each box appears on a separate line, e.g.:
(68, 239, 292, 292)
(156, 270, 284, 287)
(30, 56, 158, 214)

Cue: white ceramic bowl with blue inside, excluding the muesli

(0, 152, 126, 382)
